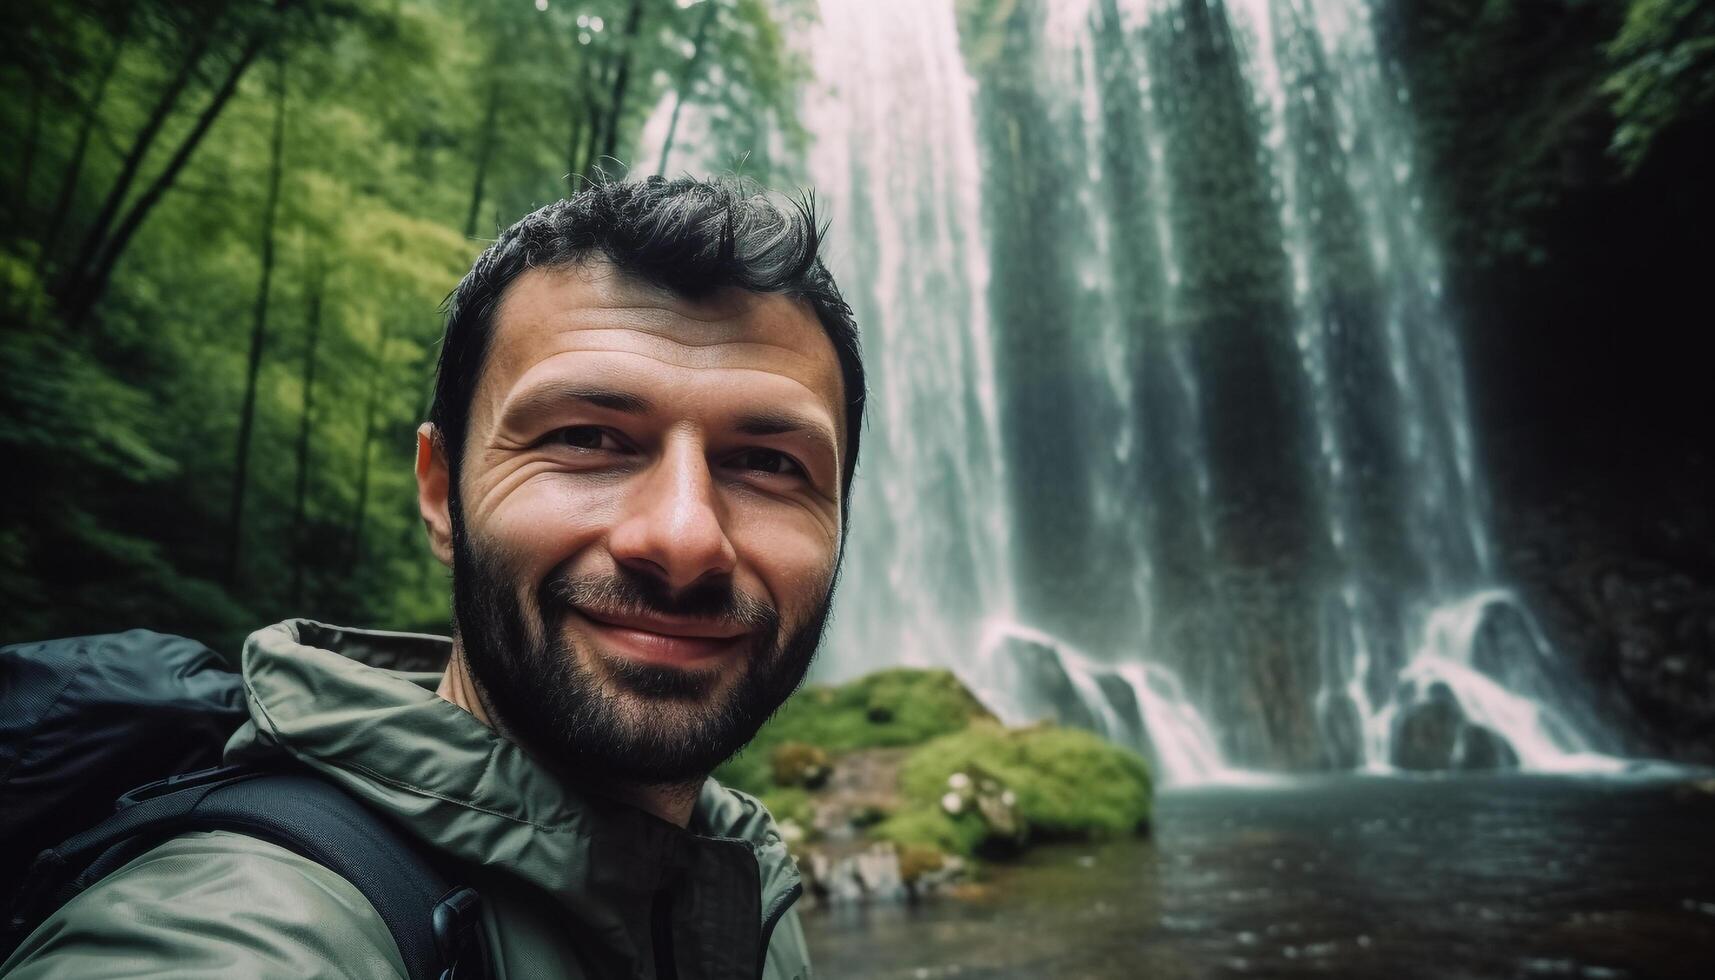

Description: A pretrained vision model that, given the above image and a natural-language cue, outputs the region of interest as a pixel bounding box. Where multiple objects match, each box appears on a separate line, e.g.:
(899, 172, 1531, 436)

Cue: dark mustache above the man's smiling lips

(542, 566, 780, 635)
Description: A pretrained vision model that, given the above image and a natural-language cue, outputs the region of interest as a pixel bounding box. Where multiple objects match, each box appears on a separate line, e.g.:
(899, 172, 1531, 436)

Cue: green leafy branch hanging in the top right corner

(1602, 0, 1715, 172)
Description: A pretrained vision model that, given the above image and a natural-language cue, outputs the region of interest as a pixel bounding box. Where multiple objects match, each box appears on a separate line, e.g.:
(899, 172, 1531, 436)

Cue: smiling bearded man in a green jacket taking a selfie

(0, 178, 864, 978)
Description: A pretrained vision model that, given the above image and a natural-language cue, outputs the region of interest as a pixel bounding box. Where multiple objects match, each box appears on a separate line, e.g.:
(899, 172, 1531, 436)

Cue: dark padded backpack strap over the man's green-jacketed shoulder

(7, 765, 489, 980)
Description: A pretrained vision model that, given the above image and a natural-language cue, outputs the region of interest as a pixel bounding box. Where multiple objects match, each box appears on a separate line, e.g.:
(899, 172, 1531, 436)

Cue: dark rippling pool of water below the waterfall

(804, 776, 1715, 980)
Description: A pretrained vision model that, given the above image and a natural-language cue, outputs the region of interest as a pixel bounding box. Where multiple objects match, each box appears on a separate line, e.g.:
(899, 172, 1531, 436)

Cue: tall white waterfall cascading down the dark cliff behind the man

(806, 0, 1610, 783)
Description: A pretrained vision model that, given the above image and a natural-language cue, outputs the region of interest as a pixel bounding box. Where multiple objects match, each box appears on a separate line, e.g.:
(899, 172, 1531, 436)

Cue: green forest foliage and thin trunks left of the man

(0, 0, 806, 649)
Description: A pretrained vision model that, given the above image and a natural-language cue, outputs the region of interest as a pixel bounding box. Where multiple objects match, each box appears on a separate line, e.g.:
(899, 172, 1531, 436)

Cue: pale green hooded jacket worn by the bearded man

(0, 620, 809, 980)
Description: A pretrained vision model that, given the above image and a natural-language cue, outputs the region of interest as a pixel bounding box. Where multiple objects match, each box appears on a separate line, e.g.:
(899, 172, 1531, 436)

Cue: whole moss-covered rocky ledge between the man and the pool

(715, 668, 1151, 901)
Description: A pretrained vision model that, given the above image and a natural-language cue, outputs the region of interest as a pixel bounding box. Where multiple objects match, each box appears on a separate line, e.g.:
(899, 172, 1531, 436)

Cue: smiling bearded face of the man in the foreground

(418, 261, 844, 783)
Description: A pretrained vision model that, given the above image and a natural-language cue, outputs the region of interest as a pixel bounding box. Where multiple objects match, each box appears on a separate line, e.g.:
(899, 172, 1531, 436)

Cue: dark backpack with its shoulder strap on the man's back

(0, 630, 487, 980)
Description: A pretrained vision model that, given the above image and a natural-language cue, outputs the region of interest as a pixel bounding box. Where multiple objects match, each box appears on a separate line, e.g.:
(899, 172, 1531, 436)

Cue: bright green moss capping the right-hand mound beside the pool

(899, 723, 1151, 838)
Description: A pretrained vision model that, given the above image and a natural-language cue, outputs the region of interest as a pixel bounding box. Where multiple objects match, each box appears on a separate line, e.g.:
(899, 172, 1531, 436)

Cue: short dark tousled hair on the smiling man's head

(429, 177, 864, 513)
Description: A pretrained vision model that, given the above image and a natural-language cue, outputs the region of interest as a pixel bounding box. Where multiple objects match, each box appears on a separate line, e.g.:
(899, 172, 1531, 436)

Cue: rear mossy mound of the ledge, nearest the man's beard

(715, 668, 993, 795)
